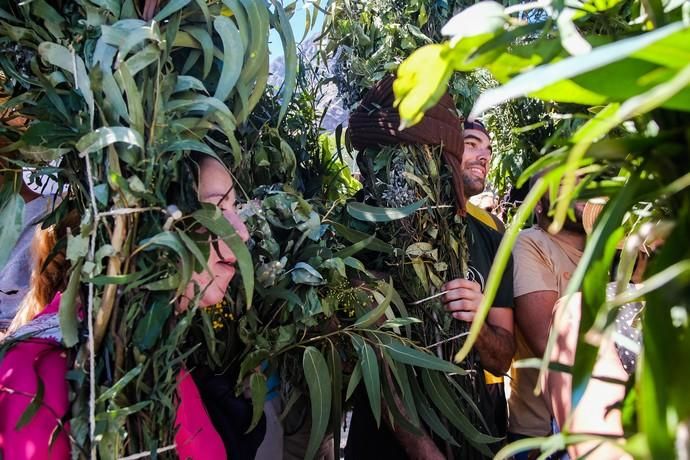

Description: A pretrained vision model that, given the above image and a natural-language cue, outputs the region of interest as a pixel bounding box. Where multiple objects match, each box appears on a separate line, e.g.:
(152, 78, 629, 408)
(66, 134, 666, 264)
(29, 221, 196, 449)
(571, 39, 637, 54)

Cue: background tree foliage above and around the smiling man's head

(322, 0, 560, 201)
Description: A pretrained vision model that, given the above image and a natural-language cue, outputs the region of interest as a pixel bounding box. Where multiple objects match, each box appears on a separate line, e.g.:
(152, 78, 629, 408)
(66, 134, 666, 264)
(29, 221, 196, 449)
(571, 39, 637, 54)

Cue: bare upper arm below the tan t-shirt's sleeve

(515, 291, 558, 357)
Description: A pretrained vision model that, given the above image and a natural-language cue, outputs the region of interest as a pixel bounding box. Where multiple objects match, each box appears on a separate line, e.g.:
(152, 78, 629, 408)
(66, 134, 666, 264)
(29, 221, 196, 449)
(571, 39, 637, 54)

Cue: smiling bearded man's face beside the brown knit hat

(462, 129, 491, 198)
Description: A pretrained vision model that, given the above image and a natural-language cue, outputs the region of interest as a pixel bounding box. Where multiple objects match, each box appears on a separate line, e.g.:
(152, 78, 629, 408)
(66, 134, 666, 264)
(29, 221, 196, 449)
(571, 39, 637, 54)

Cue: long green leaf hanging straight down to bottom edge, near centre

(302, 347, 331, 460)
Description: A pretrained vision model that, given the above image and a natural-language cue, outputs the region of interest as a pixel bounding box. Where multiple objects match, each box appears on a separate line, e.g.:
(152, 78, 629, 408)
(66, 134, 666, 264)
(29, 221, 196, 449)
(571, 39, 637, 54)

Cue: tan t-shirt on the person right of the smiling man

(508, 227, 582, 436)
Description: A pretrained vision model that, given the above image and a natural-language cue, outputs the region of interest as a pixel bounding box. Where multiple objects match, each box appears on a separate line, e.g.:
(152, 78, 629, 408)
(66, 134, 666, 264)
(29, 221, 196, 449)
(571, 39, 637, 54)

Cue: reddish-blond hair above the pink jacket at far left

(7, 212, 79, 334)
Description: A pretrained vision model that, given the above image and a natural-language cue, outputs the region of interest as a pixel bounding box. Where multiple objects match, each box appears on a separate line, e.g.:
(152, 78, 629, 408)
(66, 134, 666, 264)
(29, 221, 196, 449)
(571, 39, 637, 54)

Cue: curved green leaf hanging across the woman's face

(192, 205, 254, 308)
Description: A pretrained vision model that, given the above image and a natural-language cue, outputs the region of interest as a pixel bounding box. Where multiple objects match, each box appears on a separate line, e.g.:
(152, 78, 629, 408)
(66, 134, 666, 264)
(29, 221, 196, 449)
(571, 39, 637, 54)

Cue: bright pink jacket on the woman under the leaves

(0, 293, 227, 460)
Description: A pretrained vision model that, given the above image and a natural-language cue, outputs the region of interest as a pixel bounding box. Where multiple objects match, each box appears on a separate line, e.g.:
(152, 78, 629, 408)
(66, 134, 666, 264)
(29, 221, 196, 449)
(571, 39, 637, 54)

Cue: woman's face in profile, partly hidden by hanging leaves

(179, 157, 249, 311)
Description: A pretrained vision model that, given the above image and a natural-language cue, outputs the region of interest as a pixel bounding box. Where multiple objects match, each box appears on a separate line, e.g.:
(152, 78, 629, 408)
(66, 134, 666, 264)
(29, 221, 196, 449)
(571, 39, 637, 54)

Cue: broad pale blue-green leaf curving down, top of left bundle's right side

(213, 16, 244, 101)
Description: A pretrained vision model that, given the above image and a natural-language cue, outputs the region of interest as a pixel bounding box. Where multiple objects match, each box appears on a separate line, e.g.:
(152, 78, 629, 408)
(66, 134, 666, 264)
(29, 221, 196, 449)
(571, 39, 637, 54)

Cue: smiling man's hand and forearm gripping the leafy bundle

(441, 278, 515, 375)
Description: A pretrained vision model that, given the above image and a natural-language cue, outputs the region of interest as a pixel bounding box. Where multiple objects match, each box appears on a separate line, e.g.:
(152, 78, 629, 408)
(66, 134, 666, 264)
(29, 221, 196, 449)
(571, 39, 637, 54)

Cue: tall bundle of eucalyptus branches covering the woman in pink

(0, 0, 296, 458)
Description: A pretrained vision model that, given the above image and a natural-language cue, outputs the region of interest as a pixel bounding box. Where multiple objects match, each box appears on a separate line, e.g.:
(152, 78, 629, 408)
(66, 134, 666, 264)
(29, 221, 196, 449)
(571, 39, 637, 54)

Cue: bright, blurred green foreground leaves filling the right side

(396, 2, 690, 458)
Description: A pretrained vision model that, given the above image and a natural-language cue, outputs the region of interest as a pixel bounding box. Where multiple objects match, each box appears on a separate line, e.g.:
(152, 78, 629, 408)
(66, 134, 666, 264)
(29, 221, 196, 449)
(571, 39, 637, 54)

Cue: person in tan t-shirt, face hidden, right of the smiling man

(508, 182, 585, 460)
